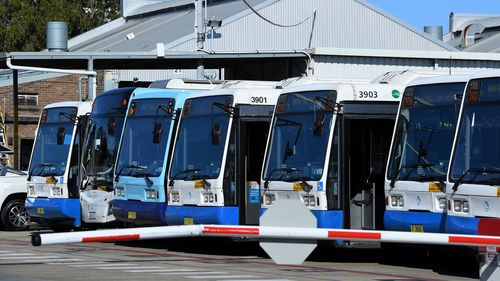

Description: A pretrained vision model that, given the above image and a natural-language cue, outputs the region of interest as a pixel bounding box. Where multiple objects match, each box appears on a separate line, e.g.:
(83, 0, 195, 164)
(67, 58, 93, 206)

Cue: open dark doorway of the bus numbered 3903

(341, 101, 397, 229)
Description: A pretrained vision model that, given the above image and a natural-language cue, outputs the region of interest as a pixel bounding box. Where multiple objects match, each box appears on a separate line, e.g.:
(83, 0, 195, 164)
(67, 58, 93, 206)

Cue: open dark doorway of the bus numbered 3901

(236, 106, 274, 225)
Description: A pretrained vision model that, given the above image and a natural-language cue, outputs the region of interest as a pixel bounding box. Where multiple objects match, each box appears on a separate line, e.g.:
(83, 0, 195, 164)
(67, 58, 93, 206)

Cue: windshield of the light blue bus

(115, 98, 175, 177)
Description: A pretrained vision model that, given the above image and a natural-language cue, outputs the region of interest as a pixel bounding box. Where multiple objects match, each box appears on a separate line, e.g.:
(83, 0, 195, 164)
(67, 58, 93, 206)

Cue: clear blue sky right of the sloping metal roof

(367, 0, 500, 34)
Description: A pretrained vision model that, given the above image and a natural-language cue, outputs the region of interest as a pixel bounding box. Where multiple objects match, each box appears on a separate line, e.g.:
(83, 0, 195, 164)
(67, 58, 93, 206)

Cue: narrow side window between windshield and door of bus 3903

(326, 118, 342, 210)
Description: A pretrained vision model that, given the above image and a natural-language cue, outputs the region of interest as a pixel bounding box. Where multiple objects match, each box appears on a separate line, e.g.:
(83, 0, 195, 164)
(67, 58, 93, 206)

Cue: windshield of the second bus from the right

(388, 82, 465, 181)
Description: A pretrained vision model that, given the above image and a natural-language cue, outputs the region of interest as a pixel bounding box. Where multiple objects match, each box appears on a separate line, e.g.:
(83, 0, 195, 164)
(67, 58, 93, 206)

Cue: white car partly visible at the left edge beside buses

(0, 166, 30, 230)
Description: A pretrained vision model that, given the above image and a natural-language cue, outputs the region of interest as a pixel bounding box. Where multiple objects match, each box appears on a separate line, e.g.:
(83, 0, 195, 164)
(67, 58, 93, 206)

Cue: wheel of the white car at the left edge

(1, 199, 30, 231)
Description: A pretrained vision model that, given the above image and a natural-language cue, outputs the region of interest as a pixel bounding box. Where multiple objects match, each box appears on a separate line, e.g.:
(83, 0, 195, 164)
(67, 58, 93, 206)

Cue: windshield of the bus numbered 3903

(264, 91, 336, 181)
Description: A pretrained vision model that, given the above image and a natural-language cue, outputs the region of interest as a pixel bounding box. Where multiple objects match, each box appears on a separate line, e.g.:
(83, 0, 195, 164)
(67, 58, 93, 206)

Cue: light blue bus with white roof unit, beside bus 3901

(112, 79, 219, 225)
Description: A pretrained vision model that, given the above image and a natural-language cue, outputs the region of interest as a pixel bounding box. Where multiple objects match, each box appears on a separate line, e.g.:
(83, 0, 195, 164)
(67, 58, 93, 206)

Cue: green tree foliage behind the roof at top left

(0, 0, 120, 52)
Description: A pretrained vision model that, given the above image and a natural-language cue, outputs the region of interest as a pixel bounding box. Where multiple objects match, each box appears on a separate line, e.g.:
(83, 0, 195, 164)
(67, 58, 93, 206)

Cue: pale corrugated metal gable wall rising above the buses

(170, 0, 452, 51)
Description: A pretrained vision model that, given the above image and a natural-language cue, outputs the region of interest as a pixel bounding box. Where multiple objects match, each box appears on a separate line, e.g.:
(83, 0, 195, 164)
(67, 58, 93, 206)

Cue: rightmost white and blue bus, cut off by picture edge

(446, 70, 500, 235)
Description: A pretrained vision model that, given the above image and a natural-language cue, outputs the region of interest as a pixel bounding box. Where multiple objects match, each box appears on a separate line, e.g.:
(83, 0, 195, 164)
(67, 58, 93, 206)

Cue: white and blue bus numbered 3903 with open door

(260, 80, 404, 229)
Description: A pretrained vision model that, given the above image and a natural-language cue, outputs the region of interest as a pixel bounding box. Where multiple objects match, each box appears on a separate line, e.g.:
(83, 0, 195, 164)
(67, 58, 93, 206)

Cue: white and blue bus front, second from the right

(384, 75, 469, 232)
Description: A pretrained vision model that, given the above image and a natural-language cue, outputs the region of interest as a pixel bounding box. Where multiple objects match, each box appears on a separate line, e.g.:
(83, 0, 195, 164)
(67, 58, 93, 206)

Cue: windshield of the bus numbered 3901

(169, 95, 233, 180)
